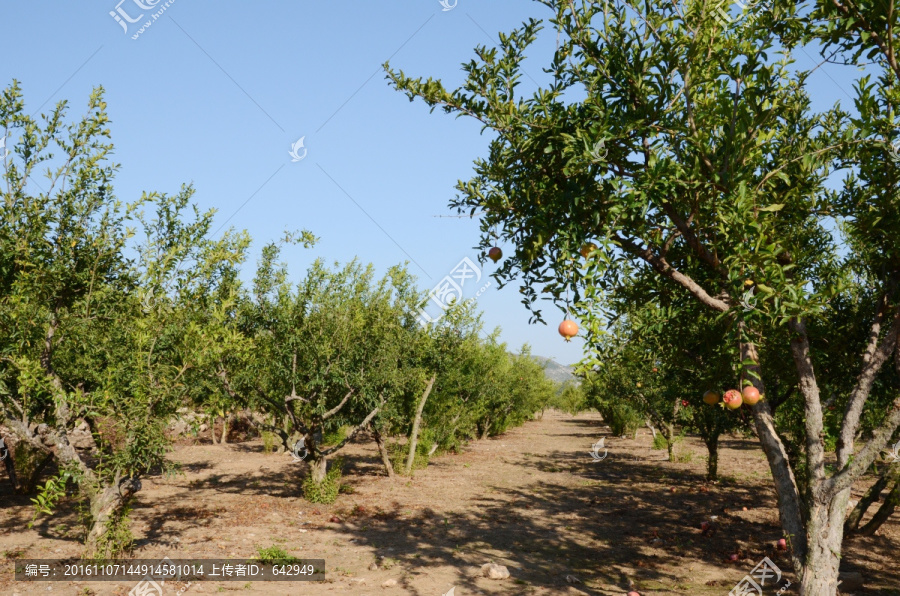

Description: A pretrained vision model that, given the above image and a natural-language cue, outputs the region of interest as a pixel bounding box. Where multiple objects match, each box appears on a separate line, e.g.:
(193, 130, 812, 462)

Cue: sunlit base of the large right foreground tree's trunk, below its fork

(800, 489, 850, 596)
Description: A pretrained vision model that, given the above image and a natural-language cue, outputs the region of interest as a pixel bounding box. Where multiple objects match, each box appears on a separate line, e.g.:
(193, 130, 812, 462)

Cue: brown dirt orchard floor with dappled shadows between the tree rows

(0, 412, 900, 596)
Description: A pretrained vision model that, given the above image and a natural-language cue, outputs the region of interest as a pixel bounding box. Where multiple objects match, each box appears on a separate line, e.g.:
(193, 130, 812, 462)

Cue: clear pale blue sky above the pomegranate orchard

(0, 0, 858, 364)
